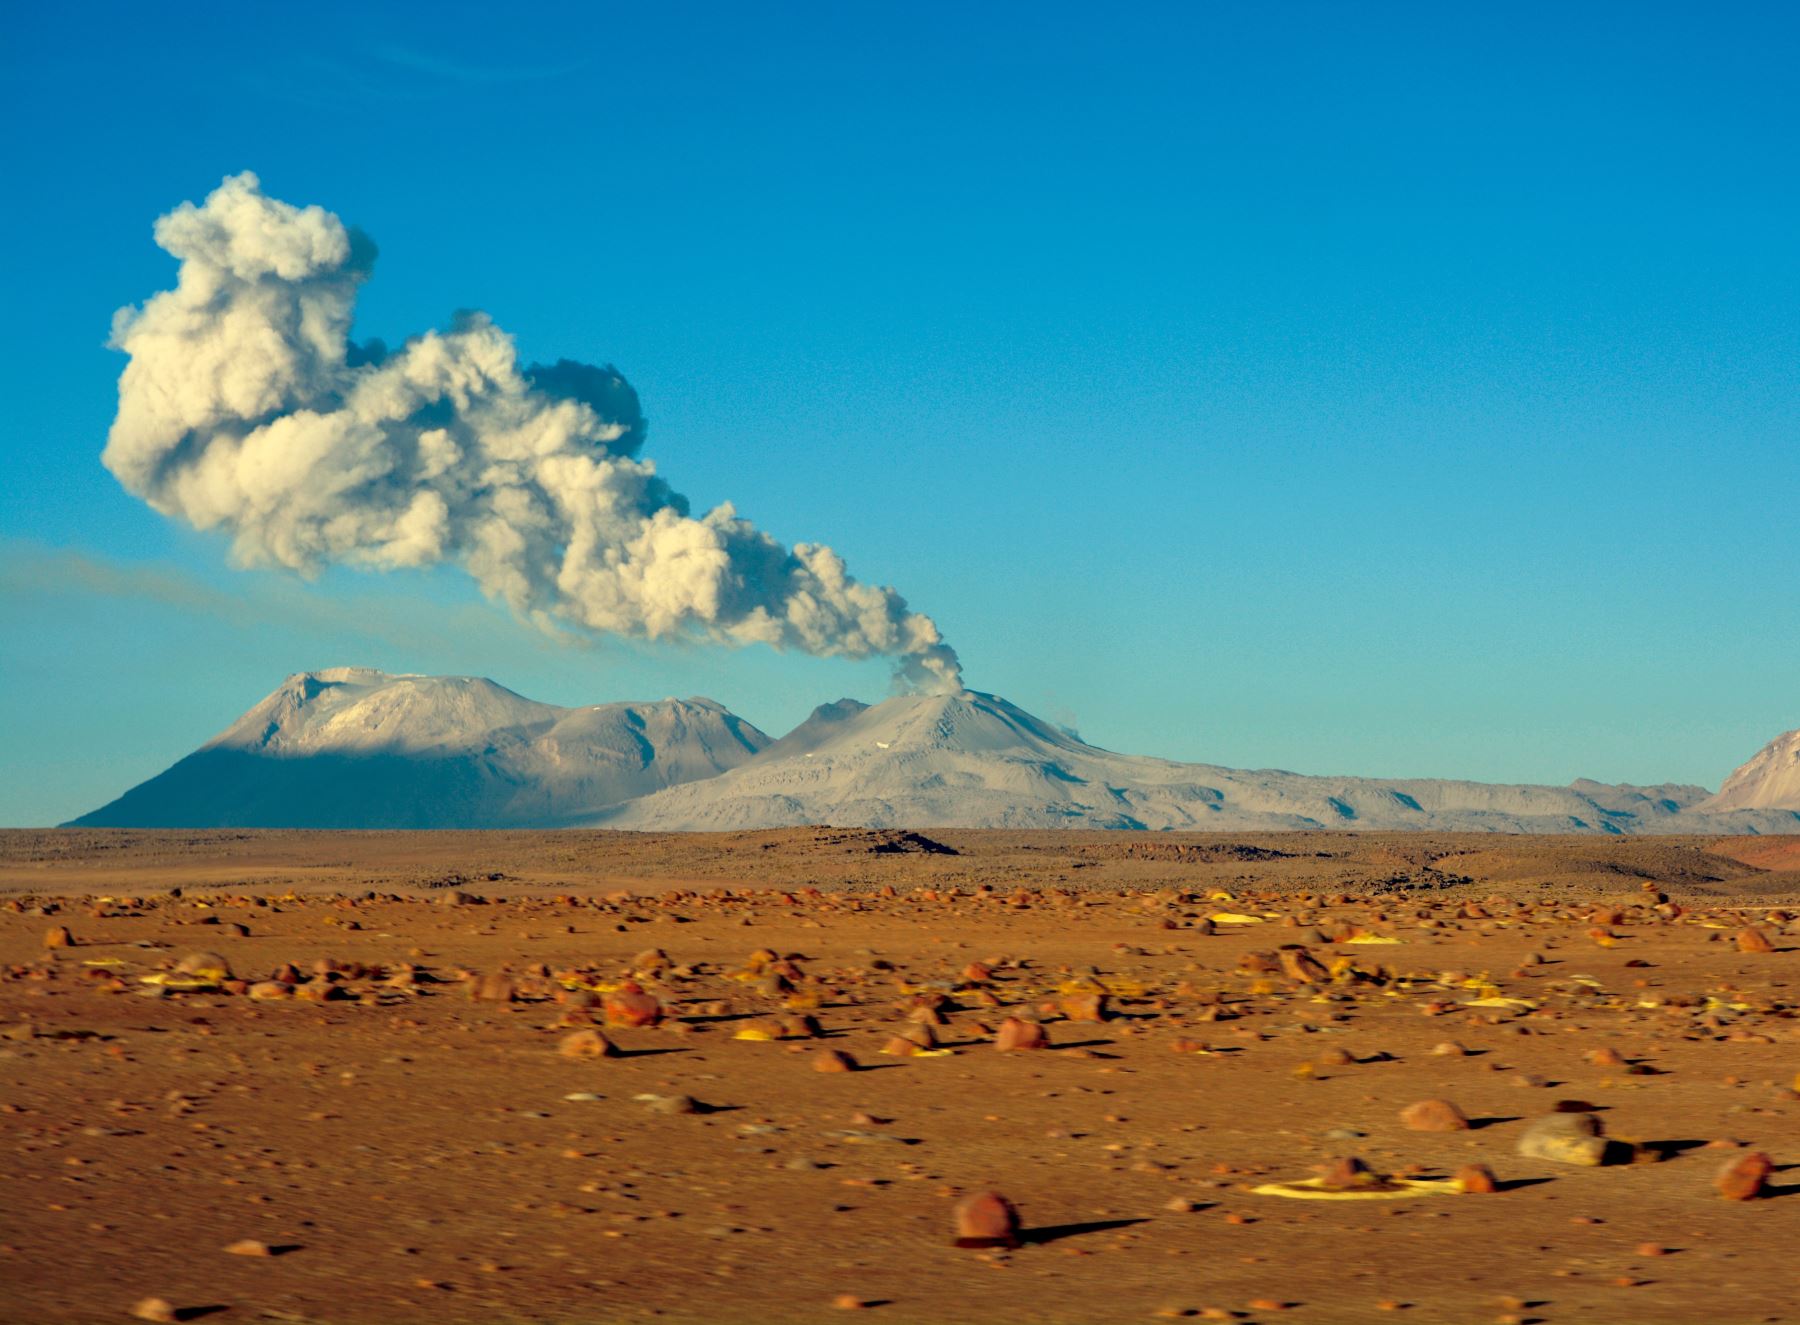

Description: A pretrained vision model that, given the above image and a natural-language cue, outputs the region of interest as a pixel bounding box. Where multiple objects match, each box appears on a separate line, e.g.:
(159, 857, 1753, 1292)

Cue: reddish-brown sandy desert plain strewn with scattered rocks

(0, 830, 1800, 1325)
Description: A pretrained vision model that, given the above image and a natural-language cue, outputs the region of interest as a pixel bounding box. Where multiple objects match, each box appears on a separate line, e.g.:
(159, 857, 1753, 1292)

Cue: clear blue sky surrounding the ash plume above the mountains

(0, 4, 1800, 823)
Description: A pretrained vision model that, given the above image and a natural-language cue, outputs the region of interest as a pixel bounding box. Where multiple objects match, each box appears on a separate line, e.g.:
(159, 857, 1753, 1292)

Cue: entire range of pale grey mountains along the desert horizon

(63, 668, 1800, 834)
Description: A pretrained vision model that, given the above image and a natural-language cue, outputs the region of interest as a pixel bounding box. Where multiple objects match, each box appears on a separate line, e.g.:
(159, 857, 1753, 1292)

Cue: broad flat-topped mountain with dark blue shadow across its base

(76, 668, 769, 828)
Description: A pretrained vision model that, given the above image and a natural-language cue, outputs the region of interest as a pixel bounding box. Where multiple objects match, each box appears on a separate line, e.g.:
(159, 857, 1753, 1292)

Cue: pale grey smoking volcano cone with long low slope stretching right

(596, 691, 1800, 834)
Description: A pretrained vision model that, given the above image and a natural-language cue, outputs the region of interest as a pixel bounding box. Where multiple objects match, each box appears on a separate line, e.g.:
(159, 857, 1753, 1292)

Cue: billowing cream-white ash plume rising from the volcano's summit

(103, 173, 961, 691)
